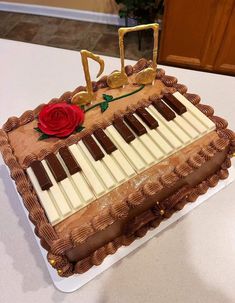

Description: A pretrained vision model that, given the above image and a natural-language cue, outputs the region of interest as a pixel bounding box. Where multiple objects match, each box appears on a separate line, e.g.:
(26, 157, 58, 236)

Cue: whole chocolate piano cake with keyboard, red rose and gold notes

(0, 24, 235, 277)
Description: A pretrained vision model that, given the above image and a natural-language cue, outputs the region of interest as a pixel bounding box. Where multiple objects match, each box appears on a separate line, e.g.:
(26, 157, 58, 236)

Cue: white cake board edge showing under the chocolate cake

(14, 167, 235, 293)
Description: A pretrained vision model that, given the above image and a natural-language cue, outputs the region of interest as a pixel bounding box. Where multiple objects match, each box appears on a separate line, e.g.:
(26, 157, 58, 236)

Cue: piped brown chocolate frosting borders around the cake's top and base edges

(0, 59, 235, 277)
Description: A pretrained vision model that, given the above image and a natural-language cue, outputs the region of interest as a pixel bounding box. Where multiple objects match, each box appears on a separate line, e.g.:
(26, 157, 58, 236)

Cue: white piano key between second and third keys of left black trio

(56, 153, 83, 209)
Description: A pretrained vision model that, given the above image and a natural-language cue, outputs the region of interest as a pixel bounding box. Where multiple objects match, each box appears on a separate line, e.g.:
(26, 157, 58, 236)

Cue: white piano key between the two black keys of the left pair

(91, 135, 126, 183)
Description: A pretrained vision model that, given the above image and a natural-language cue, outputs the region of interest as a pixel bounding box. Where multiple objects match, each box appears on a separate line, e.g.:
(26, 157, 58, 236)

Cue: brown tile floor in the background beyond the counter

(0, 11, 153, 60)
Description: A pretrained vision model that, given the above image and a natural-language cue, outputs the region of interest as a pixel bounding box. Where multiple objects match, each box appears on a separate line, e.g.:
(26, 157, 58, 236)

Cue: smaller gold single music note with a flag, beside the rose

(71, 50, 104, 105)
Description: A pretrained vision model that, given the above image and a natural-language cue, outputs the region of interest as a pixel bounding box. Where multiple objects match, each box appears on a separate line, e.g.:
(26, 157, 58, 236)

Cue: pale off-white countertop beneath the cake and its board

(0, 39, 235, 303)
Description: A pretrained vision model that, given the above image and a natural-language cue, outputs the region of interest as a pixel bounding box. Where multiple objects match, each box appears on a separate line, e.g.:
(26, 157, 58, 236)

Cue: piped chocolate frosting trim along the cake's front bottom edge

(71, 160, 228, 274)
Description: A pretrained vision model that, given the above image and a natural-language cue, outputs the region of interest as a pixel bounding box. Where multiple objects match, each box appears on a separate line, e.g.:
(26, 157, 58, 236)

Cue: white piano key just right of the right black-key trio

(146, 105, 182, 149)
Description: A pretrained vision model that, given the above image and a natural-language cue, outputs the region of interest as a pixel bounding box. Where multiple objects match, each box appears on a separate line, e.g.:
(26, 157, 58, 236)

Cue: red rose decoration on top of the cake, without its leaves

(38, 102, 84, 138)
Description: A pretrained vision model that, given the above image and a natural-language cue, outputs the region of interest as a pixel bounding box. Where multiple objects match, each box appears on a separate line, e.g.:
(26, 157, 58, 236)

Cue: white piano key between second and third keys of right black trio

(133, 112, 173, 157)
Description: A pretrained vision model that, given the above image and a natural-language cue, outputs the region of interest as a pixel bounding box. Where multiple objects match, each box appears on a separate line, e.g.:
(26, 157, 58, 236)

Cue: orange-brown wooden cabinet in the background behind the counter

(159, 0, 235, 74)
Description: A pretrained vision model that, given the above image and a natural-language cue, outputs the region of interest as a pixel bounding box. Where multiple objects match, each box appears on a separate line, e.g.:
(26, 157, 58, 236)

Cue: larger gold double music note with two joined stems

(107, 23, 158, 88)
